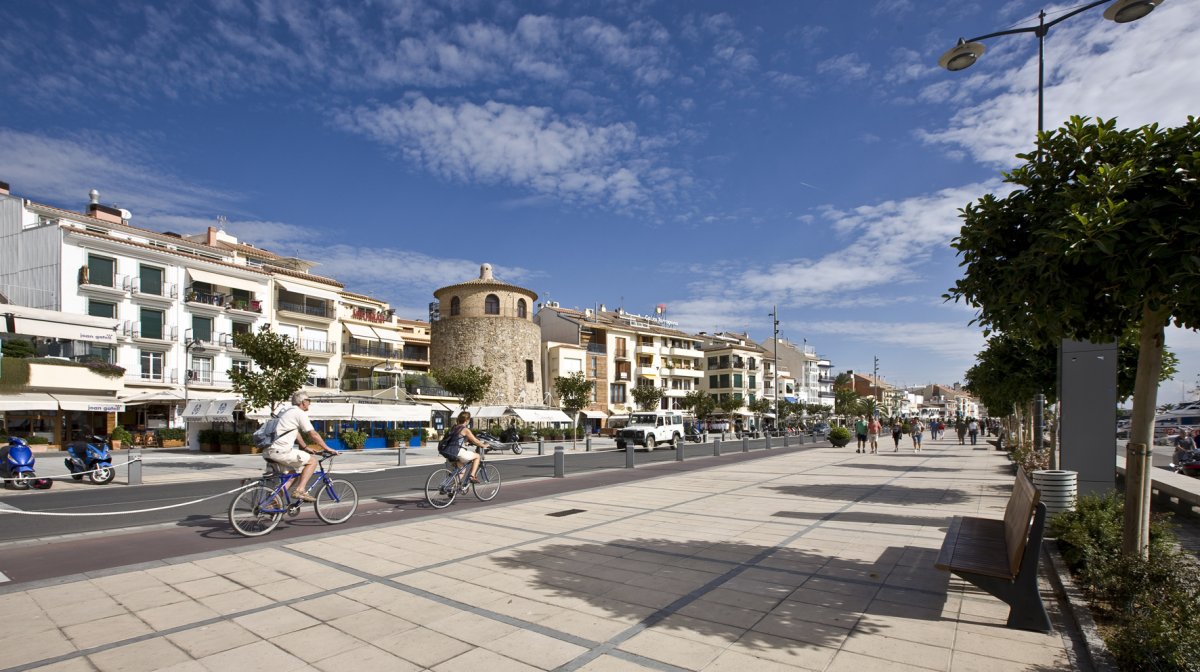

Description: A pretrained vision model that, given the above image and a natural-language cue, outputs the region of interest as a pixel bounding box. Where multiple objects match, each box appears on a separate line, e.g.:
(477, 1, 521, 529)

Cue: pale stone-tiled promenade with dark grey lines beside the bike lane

(0, 432, 1086, 672)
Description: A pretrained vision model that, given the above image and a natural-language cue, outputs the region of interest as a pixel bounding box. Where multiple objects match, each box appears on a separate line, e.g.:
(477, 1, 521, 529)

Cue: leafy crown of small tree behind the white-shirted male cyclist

(228, 324, 308, 414)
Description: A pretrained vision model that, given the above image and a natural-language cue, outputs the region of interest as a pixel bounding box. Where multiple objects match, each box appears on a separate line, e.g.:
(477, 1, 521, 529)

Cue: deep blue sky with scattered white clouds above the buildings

(0, 0, 1200, 402)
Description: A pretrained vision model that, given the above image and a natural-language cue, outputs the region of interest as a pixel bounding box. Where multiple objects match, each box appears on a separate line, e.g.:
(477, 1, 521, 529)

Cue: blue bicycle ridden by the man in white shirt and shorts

(229, 452, 359, 536)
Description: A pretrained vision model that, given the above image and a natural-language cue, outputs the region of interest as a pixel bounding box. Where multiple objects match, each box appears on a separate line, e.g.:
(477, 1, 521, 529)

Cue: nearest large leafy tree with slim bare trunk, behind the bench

(947, 116, 1200, 556)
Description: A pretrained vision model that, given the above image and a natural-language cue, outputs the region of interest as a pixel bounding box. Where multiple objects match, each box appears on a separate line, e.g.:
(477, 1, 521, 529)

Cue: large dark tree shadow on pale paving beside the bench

(492, 539, 949, 660)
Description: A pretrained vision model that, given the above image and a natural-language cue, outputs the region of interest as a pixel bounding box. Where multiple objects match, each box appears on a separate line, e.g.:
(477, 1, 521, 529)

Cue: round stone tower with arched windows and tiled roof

(430, 264, 542, 406)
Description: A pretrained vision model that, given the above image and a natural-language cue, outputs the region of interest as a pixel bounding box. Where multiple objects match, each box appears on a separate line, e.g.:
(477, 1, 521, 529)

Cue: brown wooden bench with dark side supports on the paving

(934, 469, 1050, 632)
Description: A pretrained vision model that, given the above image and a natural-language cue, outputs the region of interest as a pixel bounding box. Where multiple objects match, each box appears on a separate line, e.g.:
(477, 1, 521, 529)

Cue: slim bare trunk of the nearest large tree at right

(1121, 306, 1170, 557)
